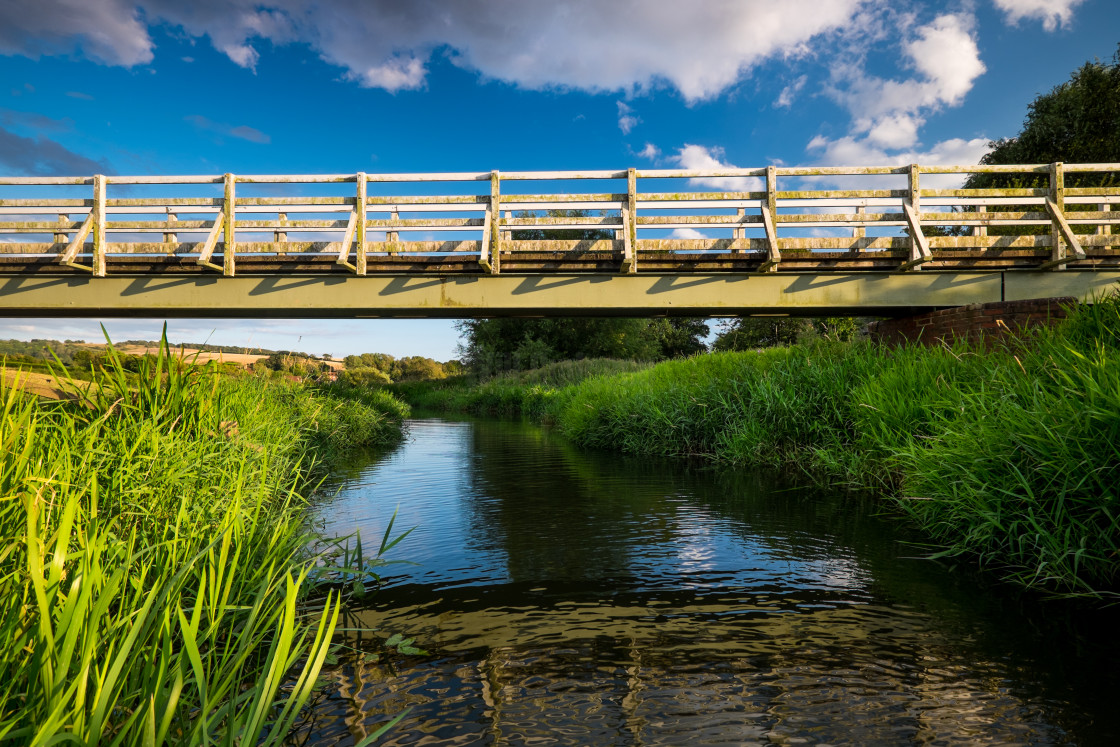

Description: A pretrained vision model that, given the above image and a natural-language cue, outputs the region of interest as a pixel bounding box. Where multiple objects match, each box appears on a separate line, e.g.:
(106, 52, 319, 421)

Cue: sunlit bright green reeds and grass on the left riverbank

(0, 342, 412, 745)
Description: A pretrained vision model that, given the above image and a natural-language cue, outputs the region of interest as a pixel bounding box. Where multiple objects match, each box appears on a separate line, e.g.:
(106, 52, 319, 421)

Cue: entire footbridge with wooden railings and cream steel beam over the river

(0, 164, 1120, 318)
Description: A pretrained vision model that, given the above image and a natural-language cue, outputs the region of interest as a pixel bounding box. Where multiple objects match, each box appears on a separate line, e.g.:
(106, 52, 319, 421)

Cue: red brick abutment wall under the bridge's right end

(867, 298, 1077, 345)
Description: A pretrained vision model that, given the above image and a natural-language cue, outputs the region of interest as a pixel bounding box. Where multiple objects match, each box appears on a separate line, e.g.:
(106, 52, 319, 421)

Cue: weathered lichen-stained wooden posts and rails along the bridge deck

(0, 162, 1120, 276)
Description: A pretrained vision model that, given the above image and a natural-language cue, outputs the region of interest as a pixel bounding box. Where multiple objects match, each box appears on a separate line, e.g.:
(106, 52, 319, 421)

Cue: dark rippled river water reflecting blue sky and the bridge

(308, 419, 1120, 745)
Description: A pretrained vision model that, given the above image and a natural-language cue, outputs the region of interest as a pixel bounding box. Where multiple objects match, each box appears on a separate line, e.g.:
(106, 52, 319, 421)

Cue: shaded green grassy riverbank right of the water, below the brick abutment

(401, 296, 1120, 598)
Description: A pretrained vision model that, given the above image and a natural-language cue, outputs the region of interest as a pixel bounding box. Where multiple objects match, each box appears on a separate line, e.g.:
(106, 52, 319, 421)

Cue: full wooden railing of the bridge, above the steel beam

(0, 164, 1120, 276)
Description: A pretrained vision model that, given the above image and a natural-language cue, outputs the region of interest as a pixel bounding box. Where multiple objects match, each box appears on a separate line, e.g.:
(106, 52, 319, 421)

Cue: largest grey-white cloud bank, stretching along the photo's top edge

(0, 0, 864, 102)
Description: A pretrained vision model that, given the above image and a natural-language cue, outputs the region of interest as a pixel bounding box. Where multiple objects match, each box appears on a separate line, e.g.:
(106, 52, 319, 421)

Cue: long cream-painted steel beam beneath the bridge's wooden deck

(0, 270, 1120, 318)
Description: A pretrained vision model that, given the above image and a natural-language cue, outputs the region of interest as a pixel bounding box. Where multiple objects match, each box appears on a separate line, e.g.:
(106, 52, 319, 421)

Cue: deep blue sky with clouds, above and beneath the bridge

(0, 0, 1120, 361)
